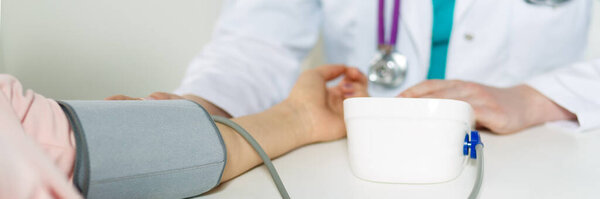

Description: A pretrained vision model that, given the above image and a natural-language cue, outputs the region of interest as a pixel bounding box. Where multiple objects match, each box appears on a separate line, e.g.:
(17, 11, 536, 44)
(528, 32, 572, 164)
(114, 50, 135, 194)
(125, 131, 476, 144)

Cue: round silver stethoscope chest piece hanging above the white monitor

(368, 51, 408, 88)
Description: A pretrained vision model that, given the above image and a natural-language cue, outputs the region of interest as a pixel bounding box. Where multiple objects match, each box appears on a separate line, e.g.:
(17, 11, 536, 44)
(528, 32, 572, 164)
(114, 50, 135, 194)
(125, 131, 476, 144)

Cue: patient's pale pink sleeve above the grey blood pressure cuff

(0, 74, 81, 198)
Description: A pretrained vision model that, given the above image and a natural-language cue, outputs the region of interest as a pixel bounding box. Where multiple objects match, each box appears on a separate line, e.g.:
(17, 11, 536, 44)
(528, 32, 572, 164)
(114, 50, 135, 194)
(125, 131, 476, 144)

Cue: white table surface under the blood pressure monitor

(202, 125, 600, 199)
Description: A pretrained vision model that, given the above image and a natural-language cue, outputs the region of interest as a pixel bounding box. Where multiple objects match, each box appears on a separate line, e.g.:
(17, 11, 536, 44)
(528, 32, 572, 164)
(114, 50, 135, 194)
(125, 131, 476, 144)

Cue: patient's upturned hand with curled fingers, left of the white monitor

(282, 65, 369, 143)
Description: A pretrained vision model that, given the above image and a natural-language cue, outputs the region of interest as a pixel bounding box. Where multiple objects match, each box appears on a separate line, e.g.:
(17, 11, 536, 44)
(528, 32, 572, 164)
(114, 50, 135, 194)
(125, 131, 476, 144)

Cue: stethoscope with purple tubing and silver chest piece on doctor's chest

(368, 0, 570, 88)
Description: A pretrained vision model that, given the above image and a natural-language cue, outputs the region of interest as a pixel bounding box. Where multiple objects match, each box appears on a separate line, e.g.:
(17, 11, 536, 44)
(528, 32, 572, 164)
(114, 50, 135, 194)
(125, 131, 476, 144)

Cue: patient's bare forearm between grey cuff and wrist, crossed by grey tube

(217, 102, 311, 182)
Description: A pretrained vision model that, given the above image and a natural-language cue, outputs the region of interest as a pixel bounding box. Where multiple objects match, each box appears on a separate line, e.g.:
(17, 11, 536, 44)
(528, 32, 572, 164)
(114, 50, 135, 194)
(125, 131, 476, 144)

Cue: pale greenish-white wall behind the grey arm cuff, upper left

(2, 0, 221, 99)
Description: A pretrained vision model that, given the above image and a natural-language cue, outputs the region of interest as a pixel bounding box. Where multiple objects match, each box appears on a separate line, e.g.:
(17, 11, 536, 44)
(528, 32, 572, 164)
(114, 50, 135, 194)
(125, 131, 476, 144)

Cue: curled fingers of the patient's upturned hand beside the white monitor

(335, 68, 369, 99)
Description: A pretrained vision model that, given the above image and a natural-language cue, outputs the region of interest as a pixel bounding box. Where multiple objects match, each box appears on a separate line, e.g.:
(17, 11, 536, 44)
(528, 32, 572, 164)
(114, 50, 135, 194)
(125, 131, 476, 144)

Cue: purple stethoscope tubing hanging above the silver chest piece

(377, 0, 400, 47)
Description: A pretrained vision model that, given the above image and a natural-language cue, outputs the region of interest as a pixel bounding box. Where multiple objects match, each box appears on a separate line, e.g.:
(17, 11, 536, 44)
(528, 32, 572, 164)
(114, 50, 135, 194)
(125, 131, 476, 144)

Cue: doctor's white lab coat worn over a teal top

(176, 0, 600, 130)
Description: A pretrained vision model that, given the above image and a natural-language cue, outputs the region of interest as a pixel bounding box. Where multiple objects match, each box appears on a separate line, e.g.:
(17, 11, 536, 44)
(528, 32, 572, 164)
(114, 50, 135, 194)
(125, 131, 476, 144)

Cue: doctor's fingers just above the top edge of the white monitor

(398, 79, 467, 97)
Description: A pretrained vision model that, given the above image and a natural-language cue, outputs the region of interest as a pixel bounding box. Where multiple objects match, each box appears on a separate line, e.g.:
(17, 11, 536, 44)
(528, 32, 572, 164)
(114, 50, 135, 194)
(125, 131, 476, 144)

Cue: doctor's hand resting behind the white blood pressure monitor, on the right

(399, 80, 575, 134)
